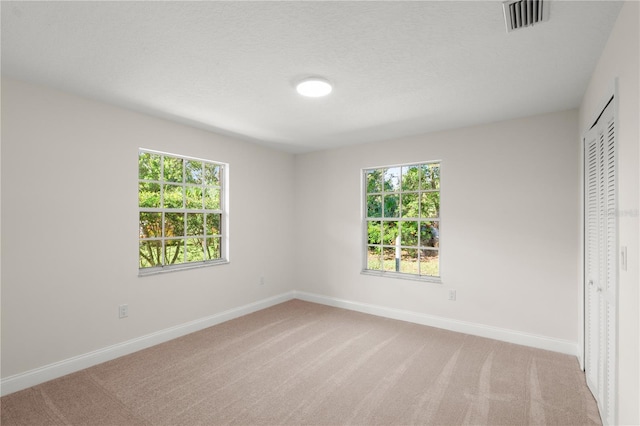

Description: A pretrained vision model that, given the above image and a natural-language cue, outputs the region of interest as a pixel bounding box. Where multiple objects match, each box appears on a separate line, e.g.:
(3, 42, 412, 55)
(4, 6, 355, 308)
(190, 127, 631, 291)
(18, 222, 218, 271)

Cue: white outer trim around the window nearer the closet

(360, 160, 443, 284)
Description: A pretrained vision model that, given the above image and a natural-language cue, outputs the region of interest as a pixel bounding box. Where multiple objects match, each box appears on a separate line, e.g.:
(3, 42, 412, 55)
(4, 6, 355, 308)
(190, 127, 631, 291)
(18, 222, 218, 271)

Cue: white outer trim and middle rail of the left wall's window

(136, 148, 230, 277)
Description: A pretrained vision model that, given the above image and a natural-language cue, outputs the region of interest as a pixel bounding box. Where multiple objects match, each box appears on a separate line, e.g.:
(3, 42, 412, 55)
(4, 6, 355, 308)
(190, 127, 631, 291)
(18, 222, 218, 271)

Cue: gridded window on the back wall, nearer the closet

(363, 162, 440, 281)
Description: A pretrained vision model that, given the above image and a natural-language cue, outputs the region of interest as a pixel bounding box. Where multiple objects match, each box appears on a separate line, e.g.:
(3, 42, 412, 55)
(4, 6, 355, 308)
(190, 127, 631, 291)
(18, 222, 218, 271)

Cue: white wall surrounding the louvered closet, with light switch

(580, 1, 640, 425)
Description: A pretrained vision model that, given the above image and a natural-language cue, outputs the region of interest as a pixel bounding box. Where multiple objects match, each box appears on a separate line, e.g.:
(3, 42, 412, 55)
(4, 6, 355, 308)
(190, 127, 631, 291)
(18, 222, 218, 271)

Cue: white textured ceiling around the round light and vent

(1, 0, 621, 152)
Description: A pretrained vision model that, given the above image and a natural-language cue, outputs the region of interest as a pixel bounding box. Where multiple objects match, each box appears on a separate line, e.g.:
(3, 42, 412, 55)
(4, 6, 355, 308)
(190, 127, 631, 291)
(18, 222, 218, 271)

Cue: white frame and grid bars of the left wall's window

(137, 148, 229, 276)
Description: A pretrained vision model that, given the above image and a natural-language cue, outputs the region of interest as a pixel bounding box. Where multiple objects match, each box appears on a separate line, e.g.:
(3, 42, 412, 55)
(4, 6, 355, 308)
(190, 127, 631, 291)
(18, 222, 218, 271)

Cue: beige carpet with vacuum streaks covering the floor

(1, 300, 600, 426)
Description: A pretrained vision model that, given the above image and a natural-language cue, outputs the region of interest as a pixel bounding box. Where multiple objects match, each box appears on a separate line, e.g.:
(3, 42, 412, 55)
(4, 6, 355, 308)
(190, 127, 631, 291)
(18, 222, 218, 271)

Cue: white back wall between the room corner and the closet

(295, 110, 581, 345)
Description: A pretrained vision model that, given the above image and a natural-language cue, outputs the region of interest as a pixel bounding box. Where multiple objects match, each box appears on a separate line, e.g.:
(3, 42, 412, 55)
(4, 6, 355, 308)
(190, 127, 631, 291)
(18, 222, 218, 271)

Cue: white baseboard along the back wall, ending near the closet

(294, 291, 579, 357)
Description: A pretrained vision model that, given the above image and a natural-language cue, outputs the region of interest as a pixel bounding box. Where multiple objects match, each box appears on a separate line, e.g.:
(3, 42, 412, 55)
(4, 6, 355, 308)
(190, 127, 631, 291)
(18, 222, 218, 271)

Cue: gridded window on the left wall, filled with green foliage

(138, 150, 227, 274)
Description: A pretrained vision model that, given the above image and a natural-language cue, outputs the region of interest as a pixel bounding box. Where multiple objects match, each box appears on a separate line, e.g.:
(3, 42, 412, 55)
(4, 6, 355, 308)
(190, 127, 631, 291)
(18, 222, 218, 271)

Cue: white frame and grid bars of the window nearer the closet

(360, 160, 443, 283)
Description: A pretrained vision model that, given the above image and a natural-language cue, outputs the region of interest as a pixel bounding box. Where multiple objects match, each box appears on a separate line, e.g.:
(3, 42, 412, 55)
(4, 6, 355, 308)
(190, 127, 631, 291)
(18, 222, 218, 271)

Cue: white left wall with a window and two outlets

(2, 79, 294, 378)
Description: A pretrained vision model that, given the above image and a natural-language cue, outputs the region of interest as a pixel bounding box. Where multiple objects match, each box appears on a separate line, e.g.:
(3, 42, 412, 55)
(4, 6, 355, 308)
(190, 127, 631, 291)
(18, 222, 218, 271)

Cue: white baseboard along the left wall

(0, 291, 294, 396)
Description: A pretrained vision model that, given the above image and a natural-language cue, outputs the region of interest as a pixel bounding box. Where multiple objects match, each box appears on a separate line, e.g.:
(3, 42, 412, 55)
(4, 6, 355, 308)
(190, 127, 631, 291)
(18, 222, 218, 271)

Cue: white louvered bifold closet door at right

(584, 97, 618, 424)
